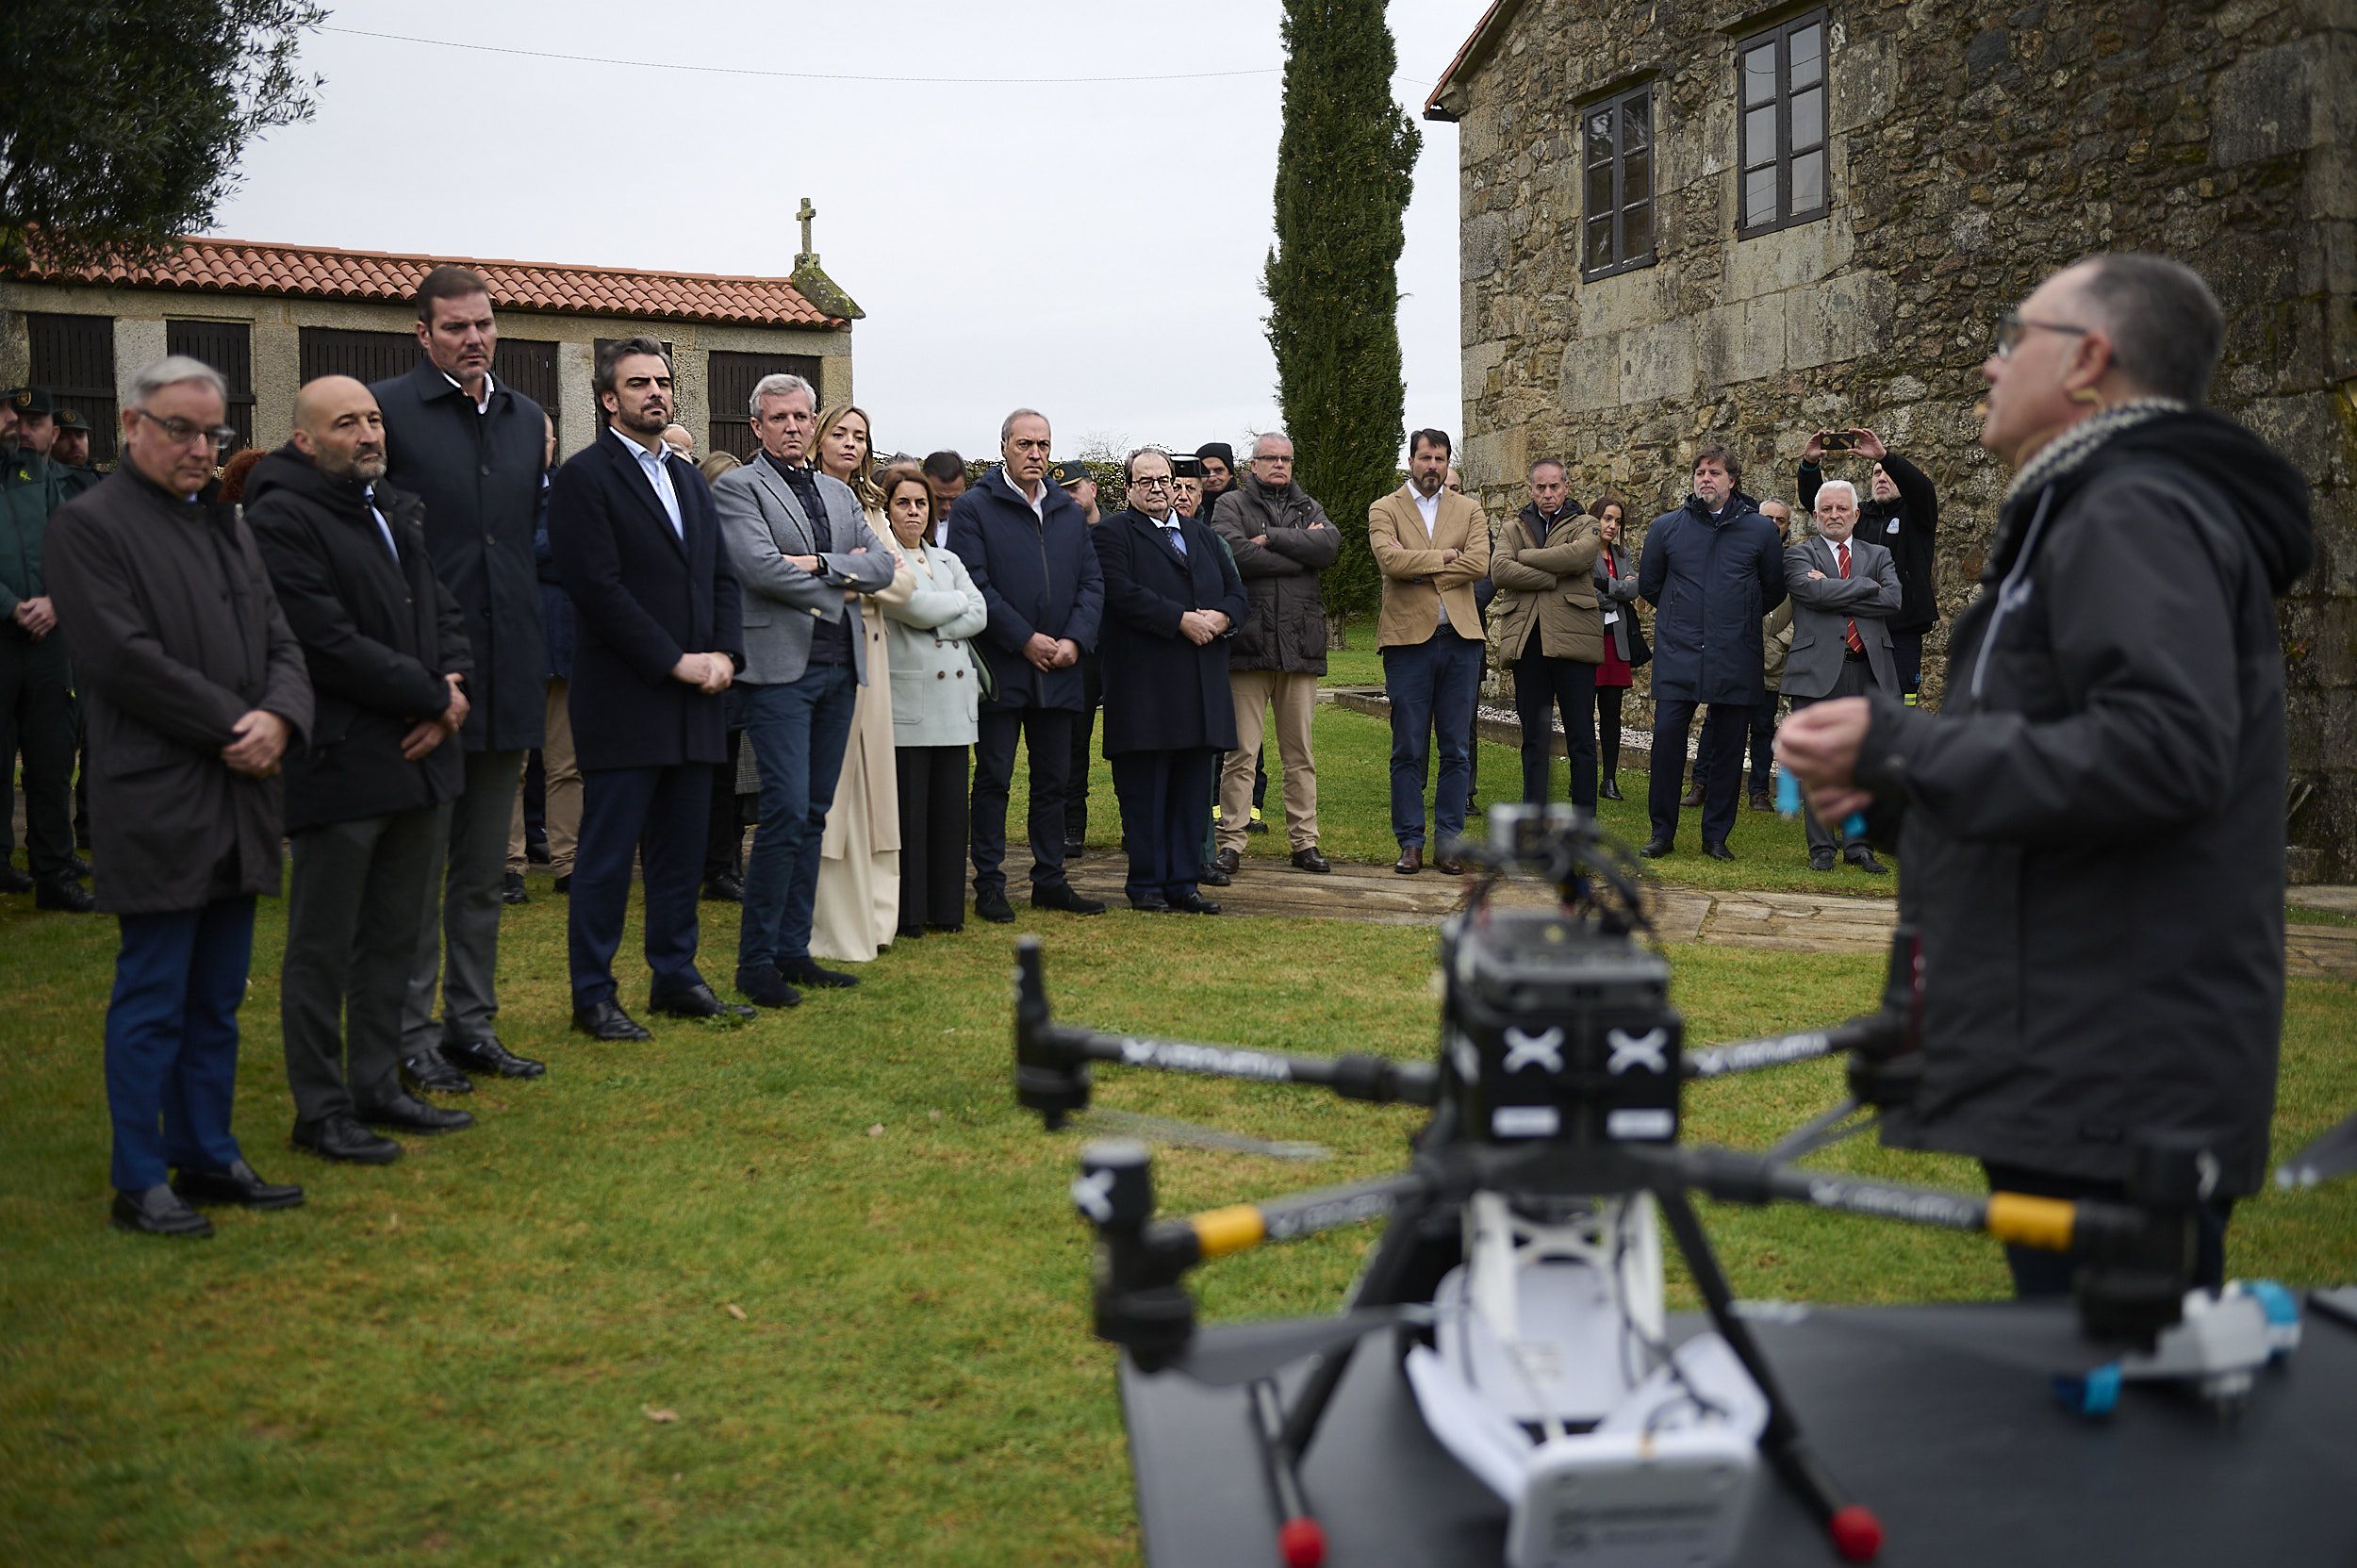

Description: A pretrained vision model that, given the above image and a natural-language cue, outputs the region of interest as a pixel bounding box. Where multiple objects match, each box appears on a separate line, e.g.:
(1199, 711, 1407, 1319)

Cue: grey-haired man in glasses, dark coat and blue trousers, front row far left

(47, 356, 311, 1235)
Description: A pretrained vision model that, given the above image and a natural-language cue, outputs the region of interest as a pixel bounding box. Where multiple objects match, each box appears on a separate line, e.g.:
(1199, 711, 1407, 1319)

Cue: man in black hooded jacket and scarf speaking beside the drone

(1777, 255, 2315, 1295)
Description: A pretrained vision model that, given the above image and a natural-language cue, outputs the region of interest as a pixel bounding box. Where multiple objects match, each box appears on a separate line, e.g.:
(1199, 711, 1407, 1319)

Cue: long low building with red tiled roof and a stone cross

(0, 231, 861, 465)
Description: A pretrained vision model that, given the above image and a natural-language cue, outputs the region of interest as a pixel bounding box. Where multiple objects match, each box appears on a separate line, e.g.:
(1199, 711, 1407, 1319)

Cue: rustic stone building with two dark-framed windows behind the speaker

(1426, 0, 2357, 880)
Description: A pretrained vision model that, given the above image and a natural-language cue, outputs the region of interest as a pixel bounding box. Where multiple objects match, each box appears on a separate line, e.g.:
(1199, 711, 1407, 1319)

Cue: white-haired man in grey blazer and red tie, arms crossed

(1785, 479, 1900, 875)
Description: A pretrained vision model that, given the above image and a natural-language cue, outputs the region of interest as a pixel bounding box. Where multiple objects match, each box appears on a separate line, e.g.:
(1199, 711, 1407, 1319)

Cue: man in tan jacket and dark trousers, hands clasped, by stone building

(1490, 507, 1606, 814)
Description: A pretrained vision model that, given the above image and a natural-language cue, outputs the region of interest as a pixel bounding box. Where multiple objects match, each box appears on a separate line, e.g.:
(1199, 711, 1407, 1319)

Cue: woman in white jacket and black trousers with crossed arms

(884, 470, 990, 936)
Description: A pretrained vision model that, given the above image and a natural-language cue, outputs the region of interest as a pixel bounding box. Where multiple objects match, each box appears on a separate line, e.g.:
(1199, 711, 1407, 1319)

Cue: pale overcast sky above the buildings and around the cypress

(212, 0, 1488, 455)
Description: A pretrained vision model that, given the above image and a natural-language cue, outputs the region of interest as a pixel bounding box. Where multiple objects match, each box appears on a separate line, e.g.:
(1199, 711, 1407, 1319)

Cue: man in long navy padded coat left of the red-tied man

(1639, 446, 1785, 861)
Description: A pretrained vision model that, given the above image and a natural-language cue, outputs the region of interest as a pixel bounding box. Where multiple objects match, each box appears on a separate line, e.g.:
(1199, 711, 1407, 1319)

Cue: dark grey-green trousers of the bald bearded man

(278, 806, 443, 1122)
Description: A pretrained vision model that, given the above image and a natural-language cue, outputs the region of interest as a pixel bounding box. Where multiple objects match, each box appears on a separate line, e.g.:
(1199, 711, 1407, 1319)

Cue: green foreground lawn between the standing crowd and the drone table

(13, 875, 2357, 1568)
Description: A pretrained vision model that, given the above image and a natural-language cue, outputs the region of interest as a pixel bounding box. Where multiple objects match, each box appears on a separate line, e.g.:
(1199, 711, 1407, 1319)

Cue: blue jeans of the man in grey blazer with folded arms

(738, 665, 861, 969)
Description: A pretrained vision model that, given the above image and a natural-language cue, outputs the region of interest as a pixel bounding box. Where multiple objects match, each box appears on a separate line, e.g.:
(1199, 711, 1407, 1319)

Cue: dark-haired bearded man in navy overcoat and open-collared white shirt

(550, 338, 752, 1040)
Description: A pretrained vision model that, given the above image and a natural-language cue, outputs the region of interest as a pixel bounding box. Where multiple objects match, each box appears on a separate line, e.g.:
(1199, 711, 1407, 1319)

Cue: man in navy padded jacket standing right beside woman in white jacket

(950, 408, 1106, 924)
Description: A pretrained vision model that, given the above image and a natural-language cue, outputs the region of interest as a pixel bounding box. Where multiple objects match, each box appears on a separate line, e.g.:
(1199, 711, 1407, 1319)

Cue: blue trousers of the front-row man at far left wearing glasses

(107, 894, 255, 1193)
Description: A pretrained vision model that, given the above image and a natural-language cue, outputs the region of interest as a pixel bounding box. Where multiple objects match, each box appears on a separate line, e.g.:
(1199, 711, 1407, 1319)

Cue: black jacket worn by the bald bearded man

(245, 443, 474, 833)
